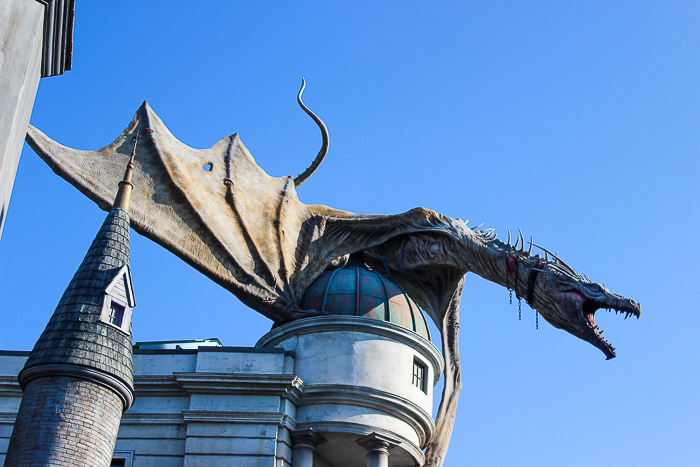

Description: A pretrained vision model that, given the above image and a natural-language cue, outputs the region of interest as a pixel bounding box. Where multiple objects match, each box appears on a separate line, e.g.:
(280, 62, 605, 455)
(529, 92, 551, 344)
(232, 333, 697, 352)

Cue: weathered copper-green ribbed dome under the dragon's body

(302, 261, 430, 340)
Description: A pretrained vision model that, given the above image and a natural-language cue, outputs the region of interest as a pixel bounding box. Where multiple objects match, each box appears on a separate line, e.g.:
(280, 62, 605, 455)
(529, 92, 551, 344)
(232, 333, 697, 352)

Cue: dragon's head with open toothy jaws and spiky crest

(527, 255, 642, 360)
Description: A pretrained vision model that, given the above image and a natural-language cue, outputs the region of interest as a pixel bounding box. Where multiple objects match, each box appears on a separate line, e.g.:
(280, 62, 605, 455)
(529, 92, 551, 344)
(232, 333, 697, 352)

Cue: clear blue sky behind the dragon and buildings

(0, 0, 700, 467)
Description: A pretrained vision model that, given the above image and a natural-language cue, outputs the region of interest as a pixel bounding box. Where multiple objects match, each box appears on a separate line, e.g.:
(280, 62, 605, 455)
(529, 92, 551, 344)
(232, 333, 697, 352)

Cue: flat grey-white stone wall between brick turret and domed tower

(0, 347, 301, 467)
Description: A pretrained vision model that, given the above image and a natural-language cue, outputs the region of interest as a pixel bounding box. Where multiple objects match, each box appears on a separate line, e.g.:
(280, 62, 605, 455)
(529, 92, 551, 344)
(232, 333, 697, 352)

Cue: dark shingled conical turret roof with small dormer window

(19, 136, 135, 410)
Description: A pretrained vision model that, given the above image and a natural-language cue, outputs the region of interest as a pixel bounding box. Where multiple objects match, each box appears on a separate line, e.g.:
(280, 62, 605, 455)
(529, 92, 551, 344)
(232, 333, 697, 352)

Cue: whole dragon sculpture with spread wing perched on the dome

(27, 82, 641, 467)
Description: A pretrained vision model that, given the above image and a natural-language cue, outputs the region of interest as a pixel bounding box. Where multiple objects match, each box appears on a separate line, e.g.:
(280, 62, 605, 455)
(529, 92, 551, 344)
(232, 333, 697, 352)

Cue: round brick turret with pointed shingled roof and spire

(5, 143, 136, 467)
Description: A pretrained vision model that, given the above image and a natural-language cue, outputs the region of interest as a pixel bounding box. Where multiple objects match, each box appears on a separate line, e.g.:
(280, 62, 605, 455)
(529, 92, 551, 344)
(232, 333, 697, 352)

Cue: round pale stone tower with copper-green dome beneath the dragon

(257, 253, 443, 467)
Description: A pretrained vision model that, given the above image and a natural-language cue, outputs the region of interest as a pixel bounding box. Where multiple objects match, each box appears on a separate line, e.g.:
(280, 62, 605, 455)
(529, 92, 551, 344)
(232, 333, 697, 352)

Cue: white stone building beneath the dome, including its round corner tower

(0, 316, 443, 467)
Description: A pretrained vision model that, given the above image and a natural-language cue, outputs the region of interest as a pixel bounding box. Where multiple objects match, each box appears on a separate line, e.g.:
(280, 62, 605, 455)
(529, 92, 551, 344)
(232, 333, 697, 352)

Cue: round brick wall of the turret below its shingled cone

(5, 376, 122, 467)
